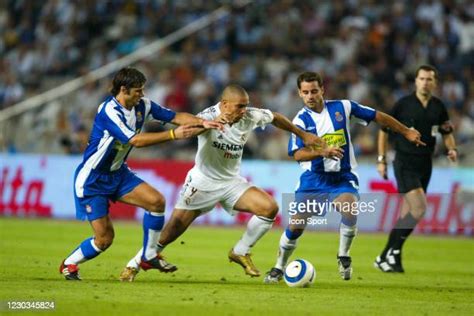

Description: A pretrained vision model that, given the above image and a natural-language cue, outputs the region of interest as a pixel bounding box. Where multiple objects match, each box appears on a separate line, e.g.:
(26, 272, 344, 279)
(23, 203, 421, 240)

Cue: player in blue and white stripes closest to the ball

(264, 72, 424, 283)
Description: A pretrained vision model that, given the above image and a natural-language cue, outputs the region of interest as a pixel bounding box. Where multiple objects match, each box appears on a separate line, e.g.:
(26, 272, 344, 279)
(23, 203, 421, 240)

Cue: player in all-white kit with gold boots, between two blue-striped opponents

(120, 85, 324, 281)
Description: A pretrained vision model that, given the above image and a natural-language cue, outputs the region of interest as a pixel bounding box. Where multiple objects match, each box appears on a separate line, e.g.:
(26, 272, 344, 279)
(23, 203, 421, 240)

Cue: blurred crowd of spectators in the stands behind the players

(0, 0, 474, 161)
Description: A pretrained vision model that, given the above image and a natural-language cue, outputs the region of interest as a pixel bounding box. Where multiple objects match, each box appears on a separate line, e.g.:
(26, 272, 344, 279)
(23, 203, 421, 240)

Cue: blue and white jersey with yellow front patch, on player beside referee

(288, 100, 376, 173)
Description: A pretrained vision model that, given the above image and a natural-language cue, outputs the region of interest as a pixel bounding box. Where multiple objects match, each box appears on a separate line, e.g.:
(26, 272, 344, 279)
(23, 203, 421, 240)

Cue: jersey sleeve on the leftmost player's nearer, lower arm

(100, 106, 135, 144)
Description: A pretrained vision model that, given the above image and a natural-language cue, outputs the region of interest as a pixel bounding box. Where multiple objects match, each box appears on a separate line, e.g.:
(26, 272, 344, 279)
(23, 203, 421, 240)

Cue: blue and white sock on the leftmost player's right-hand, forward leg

(142, 212, 165, 261)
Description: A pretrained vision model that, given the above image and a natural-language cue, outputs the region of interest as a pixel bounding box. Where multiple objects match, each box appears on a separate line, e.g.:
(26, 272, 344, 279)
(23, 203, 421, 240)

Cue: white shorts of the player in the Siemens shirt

(175, 170, 253, 215)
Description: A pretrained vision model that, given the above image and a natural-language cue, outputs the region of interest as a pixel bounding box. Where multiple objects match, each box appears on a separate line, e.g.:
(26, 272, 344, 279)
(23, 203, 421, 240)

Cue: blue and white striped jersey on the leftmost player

(78, 96, 176, 180)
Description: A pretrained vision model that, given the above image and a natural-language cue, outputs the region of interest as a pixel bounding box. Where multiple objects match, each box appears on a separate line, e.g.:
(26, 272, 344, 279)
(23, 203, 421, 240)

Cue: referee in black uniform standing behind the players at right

(374, 65, 457, 272)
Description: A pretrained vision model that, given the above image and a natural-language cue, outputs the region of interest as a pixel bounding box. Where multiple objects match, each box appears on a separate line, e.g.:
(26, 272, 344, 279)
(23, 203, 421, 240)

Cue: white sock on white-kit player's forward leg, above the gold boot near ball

(234, 215, 275, 256)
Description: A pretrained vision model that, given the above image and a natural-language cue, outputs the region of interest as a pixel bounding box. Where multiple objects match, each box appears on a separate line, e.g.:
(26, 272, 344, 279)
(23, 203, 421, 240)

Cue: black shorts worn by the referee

(393, 152, 433, 193)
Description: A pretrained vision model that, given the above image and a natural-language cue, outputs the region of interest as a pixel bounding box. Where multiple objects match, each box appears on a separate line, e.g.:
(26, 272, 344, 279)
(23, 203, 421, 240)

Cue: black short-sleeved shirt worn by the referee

(391, 92, 452, 155)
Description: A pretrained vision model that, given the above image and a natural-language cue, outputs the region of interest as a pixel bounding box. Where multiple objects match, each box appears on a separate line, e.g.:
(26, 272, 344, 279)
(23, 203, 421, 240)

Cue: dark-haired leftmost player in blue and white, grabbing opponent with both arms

(59, 68, 222, 280)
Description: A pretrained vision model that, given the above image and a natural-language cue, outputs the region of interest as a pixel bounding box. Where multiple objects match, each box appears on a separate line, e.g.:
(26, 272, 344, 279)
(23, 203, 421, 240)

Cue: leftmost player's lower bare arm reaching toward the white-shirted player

(129, 125, 202, 147)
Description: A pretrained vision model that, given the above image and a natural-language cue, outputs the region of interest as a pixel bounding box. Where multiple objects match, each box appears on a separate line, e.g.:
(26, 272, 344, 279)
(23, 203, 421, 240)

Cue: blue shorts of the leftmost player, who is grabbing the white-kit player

(74, 165, 143, 221)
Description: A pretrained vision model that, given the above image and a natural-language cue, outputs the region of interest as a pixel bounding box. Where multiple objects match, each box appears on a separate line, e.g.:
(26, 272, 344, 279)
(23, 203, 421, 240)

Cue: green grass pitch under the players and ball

(0, 218, 474, 316)
